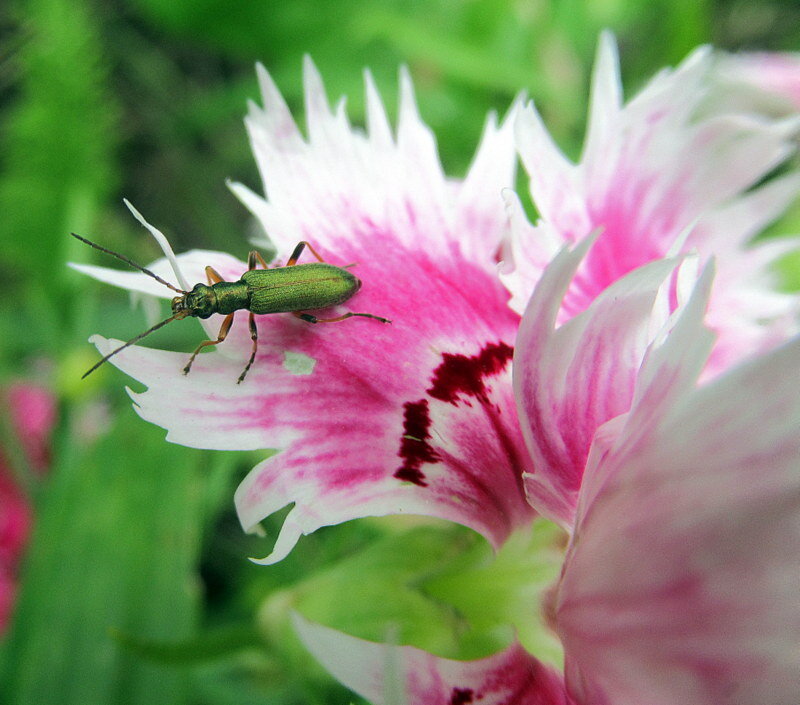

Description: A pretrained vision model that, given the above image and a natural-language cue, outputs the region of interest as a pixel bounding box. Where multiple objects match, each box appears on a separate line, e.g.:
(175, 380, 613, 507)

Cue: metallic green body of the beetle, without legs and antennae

(173, 262, 361, 318)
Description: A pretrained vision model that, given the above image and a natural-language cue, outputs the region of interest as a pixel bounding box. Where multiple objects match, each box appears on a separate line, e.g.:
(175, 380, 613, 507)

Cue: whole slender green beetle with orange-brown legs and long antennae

(72, 233, 391, 384)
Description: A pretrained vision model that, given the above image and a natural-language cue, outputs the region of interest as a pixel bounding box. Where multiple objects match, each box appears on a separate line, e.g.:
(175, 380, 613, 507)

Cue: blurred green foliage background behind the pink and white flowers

(0, 0, 800, 705)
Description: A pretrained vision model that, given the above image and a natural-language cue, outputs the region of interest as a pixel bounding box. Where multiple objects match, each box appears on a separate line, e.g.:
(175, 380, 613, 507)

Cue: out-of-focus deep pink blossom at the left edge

(0, 382, 56, 632)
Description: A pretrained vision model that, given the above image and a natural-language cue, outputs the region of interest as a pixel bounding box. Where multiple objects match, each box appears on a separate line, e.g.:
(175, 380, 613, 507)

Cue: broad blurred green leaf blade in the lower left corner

(2, 419, 207, 705)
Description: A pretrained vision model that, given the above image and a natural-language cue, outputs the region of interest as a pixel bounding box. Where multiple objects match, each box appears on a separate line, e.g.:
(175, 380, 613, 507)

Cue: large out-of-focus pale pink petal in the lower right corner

(557, 330, 800, 705)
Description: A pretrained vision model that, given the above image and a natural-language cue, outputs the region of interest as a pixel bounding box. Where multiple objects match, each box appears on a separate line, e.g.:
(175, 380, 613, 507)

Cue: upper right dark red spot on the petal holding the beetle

(427, 343, 514, 404)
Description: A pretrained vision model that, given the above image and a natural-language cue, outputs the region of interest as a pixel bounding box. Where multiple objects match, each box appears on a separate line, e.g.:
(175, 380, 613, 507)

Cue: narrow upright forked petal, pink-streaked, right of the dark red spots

(514, 240, 675, 530)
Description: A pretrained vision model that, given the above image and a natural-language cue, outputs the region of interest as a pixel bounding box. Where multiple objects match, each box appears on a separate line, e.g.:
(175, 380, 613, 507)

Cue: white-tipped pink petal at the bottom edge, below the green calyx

(294, 615, 572, 705)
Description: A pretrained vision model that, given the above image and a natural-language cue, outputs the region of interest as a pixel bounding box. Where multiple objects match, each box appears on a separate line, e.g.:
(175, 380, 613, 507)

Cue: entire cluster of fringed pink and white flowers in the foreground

(73, 36, 800, 705)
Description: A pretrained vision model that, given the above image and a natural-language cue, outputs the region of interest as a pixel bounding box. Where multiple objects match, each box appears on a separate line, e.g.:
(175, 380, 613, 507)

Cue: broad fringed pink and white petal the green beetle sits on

(78, 62, 534, 562)
